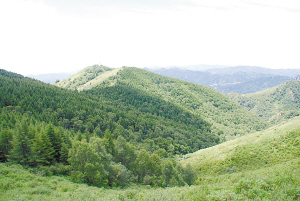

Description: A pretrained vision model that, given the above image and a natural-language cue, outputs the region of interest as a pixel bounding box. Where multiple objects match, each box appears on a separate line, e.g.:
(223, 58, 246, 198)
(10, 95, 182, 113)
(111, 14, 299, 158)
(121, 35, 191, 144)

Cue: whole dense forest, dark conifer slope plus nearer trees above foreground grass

(0, 70, 219, 187)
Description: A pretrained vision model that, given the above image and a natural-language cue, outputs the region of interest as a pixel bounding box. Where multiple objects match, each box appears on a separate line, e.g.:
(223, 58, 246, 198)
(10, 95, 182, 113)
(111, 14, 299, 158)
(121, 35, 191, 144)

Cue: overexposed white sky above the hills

(0, 0, 300, 75)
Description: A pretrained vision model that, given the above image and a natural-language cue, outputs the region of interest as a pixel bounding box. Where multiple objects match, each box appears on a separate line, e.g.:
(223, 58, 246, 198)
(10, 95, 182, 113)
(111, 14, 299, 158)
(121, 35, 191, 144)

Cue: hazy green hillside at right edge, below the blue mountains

(227, 80, 300, 124)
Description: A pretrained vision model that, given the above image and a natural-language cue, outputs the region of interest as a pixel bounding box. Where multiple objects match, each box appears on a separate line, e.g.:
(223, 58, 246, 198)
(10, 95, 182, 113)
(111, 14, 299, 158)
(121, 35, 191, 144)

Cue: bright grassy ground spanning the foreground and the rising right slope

(0, 118, 300, 200)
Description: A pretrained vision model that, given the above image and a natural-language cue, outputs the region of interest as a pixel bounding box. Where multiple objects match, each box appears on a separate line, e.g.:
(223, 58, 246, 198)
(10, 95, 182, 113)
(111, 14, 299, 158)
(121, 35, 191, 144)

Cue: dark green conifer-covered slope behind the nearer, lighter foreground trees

(0, 70, 219, 154)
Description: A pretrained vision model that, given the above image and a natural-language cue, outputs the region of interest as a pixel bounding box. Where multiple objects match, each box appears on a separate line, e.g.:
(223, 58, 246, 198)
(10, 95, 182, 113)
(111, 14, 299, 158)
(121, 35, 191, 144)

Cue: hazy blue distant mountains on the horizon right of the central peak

(147, 66, 300, 94)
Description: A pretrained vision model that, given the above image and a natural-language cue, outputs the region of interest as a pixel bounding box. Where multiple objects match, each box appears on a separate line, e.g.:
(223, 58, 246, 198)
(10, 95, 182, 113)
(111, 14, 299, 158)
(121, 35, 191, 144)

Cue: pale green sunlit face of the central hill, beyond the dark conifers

(114, 68, 266, 139)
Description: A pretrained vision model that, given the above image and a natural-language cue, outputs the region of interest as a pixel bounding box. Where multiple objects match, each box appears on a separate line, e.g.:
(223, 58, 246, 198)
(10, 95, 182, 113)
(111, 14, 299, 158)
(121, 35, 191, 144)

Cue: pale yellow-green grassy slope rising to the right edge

(182, 117, 300, 177)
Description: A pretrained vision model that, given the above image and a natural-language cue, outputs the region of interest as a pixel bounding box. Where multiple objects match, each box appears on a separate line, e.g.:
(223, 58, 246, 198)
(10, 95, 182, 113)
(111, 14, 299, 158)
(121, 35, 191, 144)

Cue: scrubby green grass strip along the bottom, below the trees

(0, 159, 300, 201)
